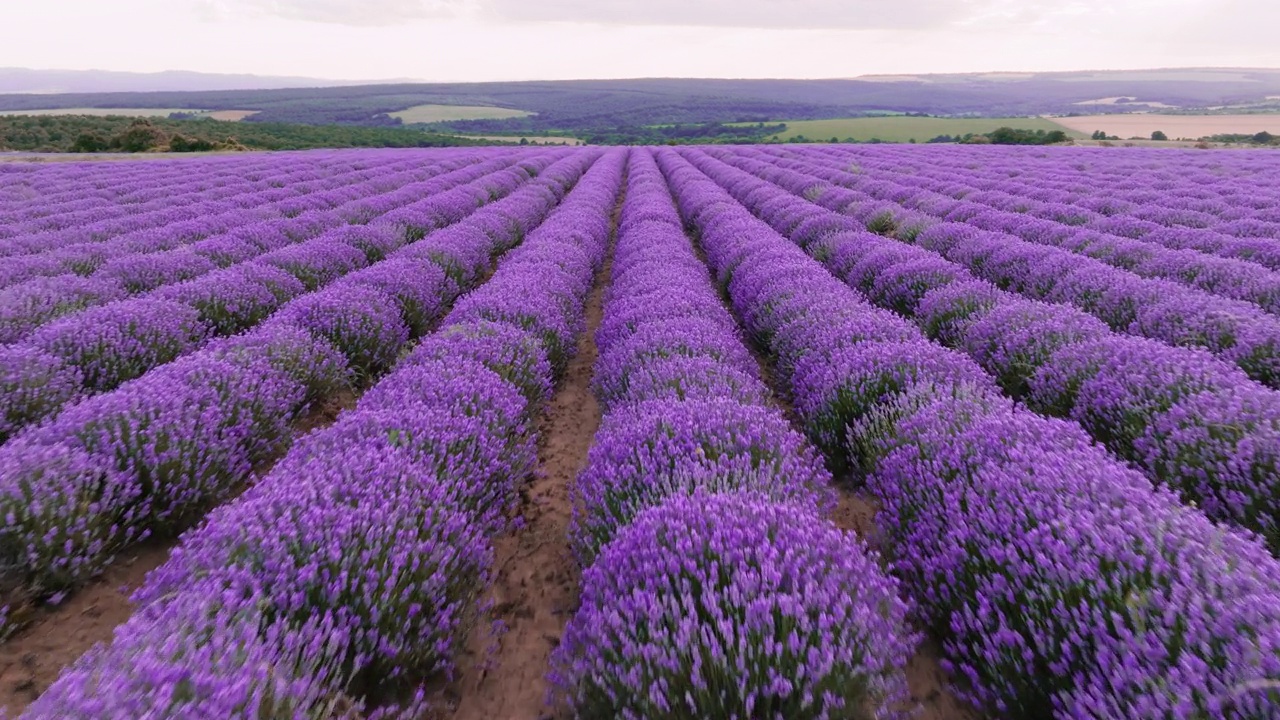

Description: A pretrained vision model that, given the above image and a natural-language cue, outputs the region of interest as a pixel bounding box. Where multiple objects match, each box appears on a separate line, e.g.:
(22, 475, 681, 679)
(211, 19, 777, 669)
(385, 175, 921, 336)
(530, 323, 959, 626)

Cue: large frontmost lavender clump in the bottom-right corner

(868, 396, 1280, 717)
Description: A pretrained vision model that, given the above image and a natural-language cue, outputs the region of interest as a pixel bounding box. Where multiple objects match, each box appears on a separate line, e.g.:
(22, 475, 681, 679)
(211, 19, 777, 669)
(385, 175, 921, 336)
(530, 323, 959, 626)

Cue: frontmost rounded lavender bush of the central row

(552, 493, 914, 719)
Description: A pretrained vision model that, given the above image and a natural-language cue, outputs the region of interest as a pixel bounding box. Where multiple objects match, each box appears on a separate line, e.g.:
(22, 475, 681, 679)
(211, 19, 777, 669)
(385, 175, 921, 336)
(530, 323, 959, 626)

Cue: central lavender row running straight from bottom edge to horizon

(550, 150, 913, 719)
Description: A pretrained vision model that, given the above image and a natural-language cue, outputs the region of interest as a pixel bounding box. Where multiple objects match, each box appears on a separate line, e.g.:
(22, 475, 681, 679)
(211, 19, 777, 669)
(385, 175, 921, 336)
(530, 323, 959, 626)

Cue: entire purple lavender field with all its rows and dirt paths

(0, 145, 1280, 720)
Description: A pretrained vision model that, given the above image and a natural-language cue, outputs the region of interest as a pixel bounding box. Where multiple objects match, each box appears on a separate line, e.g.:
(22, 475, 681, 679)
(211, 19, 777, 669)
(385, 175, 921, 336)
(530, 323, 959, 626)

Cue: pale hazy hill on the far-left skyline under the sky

(0, 68, 399, 95)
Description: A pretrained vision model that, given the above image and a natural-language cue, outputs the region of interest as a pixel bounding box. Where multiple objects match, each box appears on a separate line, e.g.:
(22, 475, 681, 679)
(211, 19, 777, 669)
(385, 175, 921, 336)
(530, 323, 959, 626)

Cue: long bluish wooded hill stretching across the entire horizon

(0, 68, 1280, 133)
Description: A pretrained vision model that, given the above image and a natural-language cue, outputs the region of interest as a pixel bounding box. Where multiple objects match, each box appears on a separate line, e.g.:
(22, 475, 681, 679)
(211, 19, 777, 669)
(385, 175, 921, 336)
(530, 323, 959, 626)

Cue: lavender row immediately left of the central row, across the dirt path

(17, 152, 625, 719)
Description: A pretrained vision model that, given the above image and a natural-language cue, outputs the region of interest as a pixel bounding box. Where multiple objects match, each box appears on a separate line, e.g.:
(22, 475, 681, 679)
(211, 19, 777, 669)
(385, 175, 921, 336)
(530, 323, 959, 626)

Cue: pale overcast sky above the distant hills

(0, 0, 1280, 81)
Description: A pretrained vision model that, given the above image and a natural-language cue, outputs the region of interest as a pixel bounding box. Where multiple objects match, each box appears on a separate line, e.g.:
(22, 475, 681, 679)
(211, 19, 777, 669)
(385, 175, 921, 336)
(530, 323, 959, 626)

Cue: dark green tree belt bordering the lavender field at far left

(0, 115, 489, 152)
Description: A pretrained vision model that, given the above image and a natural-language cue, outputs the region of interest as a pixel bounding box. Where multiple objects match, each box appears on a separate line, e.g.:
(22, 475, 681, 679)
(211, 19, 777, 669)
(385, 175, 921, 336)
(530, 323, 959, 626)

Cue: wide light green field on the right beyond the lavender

(752, 115, 1088, 142)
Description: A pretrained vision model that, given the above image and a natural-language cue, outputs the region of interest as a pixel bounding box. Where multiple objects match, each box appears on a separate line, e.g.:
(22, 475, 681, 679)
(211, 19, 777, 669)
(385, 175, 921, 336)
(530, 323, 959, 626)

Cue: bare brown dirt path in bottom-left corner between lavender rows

(0, 391, 356, 717)
